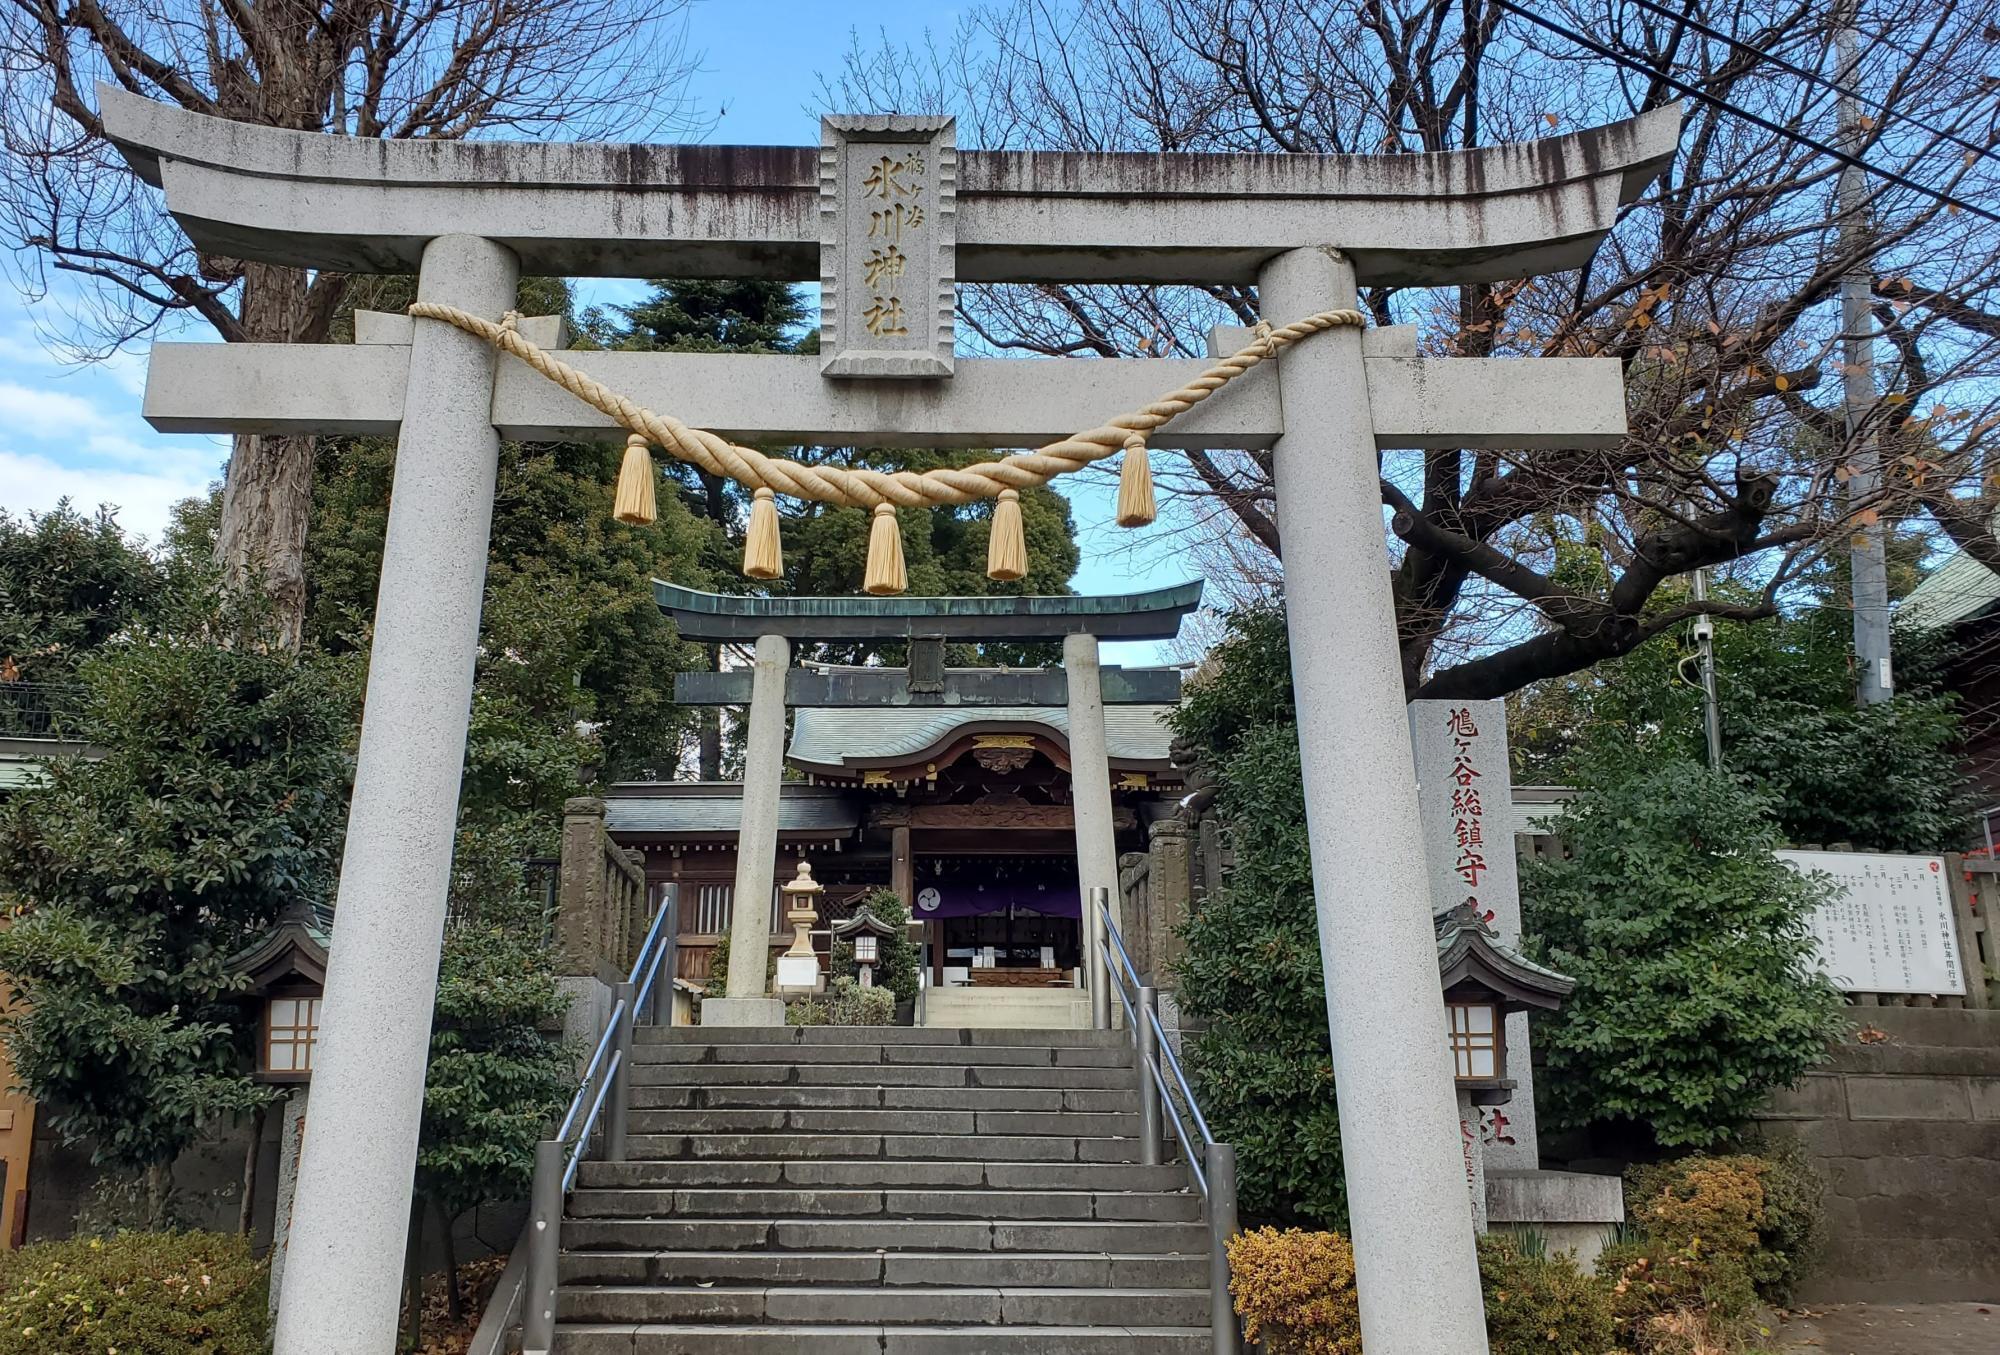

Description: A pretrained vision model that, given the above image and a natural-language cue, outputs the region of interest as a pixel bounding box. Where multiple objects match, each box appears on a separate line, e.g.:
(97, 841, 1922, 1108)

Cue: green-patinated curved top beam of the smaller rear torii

(652, 580, 1202, 640)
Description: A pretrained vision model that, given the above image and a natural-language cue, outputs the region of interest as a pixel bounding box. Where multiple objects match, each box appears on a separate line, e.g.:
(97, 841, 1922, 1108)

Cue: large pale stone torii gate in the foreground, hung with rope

(100, 88, 1678, 1355)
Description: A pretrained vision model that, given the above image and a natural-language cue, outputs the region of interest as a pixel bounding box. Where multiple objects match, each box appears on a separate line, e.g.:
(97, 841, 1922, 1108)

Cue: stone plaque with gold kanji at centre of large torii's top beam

(820, 114, 958, 378)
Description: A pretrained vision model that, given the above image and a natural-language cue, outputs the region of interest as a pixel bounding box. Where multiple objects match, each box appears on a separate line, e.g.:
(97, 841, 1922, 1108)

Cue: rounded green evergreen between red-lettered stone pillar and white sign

(1522, 749, 1846, 1147)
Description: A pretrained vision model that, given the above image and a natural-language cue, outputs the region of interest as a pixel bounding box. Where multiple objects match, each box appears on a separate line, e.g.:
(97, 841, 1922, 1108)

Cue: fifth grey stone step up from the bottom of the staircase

(570, 1187, 1202, 1223)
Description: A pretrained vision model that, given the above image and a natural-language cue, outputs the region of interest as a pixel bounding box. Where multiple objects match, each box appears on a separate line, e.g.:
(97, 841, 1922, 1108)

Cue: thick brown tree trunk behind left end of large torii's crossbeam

(216, 264, 338, 648)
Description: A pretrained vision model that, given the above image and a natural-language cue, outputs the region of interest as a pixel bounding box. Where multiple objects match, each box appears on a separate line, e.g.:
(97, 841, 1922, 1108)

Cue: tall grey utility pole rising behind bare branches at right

(1834, 0, 1896, 705)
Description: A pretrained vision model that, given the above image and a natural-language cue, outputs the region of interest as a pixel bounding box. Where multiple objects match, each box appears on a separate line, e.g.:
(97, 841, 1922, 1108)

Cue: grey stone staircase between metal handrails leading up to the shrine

(556, 1027, 1212, 1355)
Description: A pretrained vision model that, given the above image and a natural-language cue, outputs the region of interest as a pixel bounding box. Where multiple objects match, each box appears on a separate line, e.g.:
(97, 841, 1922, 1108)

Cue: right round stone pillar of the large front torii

(1258, 250, 1486, 1355)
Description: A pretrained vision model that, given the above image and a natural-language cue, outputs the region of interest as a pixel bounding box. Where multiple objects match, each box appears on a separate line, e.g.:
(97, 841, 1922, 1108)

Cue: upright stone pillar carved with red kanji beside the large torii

(1410, 701, 1540, 1171)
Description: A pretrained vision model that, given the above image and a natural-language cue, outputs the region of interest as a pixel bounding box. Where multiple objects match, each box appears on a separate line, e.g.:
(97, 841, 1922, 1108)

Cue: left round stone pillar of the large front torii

(276, 236, 520, 1355)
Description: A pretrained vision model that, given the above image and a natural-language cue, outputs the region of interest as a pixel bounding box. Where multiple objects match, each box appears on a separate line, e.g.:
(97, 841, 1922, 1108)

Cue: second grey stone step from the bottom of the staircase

(556, 1285, 1208, 1327)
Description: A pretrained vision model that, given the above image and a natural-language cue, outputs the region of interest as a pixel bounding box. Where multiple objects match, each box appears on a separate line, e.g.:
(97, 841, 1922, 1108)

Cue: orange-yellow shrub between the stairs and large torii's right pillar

(1230, 1227, 1362, 1355)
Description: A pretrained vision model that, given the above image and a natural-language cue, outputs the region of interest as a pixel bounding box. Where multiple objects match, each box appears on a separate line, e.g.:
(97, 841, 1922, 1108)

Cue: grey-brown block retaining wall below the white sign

(1762, 1007, 2000, 1303)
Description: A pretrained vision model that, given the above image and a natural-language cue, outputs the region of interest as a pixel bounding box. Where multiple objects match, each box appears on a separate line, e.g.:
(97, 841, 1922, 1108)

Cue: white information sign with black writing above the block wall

(1778, 851, 1966, 995)
